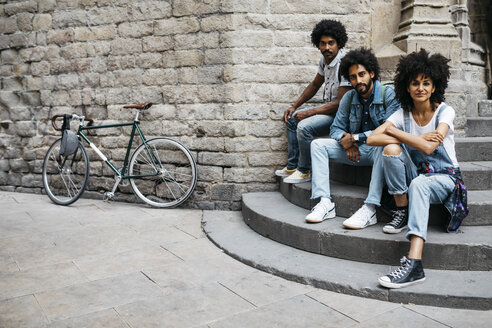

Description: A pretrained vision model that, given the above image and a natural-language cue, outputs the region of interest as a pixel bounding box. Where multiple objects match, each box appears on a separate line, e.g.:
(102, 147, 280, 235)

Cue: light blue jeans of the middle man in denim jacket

(311, 139, 384, 206)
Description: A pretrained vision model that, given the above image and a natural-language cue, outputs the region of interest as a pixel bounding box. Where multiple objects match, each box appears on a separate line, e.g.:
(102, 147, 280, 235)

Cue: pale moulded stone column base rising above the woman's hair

(393, 0, 461, 66)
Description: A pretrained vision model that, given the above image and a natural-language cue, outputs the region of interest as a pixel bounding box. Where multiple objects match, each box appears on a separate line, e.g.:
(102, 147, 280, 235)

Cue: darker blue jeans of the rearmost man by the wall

(287, 108, 334, 173)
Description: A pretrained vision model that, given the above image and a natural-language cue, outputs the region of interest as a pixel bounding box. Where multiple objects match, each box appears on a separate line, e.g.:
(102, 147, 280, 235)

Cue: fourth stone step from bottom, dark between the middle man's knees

(330, 161, 492, 190)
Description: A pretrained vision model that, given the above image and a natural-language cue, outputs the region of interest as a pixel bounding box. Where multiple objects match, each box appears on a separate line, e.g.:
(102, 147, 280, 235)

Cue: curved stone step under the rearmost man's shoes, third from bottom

(280, 179, 492, 226)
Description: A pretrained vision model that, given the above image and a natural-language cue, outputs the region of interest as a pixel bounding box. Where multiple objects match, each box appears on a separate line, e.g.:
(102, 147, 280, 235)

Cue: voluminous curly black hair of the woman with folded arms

(395, 49, 449, 111)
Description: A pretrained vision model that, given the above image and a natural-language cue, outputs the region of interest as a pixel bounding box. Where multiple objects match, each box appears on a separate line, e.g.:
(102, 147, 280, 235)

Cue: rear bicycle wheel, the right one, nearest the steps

(129, 138, 197, 207)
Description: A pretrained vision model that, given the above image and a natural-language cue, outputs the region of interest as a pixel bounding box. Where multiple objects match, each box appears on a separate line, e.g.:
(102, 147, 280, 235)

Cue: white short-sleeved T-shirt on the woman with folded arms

(388, 103, 459, 167)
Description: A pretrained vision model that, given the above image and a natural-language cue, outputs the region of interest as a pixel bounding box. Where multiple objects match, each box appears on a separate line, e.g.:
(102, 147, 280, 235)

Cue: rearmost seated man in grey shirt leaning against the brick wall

(275, 20, 350, 183)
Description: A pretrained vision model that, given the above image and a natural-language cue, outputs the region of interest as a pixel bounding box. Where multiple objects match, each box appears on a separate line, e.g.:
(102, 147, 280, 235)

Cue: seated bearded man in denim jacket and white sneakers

(306, 48, 400, 229)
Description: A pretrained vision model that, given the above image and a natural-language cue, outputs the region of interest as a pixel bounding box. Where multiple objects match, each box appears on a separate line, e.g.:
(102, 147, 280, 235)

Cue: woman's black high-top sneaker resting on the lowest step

(378, 256, 425, 288)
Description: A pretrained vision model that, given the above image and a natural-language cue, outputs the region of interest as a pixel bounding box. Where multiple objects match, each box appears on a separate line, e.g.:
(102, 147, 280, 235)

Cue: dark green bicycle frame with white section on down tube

(77, 120, 161, 179)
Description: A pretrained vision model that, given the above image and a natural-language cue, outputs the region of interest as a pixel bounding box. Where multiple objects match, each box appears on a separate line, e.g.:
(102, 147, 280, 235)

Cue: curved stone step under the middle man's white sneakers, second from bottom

(242, 192, 492, 271)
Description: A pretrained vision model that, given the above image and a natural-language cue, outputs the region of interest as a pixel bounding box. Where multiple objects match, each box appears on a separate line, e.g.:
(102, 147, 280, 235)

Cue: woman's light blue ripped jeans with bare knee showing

(383, 152, 454, 240)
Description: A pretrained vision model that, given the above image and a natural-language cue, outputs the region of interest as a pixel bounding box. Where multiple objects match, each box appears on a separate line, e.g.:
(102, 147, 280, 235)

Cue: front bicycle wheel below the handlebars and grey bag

(43, 138, 89, 205)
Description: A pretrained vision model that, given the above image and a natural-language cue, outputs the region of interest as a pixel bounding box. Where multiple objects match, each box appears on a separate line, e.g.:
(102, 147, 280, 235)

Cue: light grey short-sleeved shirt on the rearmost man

(318, 49, 351, 103)
